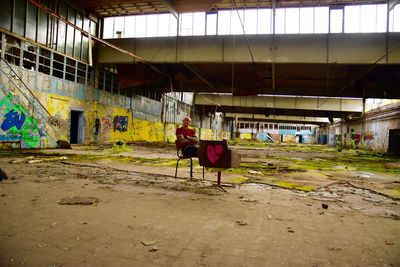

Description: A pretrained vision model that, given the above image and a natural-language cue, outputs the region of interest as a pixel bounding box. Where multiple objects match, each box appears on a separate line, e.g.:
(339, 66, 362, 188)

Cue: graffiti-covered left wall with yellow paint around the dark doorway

(0, 66, 230, 148)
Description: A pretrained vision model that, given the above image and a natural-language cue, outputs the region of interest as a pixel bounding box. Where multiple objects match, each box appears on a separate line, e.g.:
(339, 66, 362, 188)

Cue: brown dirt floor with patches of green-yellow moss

(0, 142, 400, 267)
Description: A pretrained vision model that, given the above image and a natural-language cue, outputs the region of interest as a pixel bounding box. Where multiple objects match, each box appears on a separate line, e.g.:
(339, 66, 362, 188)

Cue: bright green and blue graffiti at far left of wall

(0, 93, 40, 147)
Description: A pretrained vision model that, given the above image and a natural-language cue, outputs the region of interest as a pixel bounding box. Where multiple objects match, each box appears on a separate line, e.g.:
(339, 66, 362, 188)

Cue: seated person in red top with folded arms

(176, 117, 198, 157)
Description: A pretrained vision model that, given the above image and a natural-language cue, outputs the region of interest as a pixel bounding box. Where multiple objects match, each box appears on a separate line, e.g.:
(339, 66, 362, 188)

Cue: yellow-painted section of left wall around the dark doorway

(18, 92, 229, 148)
